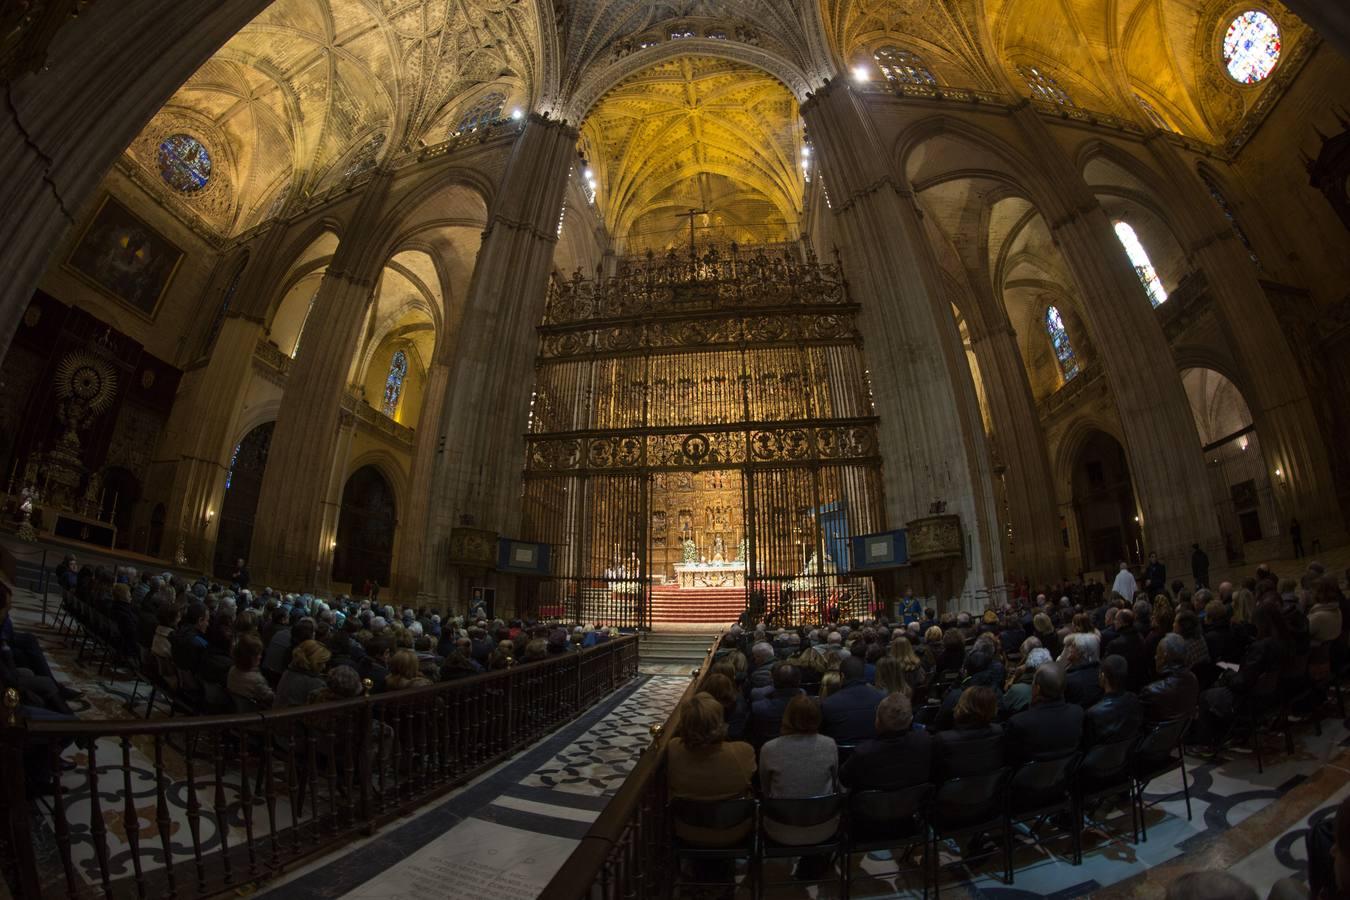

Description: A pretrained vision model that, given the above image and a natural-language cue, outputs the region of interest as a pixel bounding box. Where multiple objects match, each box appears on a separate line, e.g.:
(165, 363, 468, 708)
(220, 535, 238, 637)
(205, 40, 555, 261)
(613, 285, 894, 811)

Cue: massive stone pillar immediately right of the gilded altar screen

(802, 77, 1003, 606)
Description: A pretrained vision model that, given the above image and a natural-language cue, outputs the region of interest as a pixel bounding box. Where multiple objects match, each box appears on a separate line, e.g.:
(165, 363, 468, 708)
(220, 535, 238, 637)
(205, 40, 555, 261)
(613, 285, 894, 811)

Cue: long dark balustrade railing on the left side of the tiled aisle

(0, 637, 637, 897)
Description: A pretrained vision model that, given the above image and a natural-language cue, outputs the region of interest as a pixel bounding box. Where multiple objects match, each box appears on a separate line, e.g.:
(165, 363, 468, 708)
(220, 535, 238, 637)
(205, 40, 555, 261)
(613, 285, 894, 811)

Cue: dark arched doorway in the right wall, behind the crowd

(1073, 432, 1143, 572)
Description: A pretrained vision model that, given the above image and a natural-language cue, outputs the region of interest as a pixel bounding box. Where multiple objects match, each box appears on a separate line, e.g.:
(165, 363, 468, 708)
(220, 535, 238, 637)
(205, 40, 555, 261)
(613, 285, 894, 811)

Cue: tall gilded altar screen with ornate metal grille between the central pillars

(524, 246, 886, 625)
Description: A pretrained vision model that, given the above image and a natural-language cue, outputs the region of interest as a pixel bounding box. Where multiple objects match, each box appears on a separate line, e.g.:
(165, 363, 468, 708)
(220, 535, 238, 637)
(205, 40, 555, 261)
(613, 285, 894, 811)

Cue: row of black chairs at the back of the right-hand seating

(670, 718, 1191, 899)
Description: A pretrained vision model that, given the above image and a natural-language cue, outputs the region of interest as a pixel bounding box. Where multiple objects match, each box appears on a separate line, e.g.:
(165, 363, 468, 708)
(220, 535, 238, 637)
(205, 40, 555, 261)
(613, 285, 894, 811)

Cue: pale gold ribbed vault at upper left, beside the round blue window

(130, 0, 540, 233)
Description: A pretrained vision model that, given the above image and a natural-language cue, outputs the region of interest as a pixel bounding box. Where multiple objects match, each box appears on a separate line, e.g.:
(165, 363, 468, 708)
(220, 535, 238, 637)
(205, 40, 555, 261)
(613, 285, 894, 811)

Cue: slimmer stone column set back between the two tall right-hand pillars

(965, 297, 1065, 584)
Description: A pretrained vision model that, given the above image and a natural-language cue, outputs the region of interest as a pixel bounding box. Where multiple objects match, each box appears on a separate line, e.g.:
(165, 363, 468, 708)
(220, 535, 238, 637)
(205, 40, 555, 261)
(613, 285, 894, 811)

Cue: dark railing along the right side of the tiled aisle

(539, 634, 722, 900)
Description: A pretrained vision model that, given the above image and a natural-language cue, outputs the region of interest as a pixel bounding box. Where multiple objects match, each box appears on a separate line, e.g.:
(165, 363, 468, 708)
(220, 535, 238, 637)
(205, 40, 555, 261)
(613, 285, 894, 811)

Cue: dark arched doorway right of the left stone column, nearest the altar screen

(332, 466, 398, 594)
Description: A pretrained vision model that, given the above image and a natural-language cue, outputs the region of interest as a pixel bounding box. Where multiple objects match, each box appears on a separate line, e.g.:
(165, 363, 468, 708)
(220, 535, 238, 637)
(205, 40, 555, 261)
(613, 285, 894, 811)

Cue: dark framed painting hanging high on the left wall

(66, 194, 184, 318)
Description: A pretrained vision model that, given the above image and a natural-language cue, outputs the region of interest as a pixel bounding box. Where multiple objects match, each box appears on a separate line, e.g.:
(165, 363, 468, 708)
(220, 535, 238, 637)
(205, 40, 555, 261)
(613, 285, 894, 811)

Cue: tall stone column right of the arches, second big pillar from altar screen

(1013, 103, 1222, 572)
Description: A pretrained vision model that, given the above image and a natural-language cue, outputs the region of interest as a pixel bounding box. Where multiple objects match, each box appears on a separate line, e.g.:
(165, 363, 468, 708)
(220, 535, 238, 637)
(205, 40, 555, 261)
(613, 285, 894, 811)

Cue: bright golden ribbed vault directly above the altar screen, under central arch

(582, 57, 802, 251)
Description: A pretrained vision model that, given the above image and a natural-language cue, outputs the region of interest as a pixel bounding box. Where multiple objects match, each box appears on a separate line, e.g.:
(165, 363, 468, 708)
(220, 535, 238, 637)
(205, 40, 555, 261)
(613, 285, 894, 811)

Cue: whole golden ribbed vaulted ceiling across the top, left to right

(128, 0, 1308, 238)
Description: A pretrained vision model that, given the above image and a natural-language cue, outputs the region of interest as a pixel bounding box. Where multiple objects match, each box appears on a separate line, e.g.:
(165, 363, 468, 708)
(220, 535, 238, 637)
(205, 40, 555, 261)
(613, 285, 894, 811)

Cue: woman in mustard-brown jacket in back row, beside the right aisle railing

(666, 691, 755, 846)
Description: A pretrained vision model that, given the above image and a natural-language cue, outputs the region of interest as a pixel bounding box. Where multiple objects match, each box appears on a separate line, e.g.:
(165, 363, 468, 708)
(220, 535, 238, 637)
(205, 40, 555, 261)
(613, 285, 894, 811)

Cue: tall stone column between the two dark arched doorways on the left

(251, 171, 390, 590)
